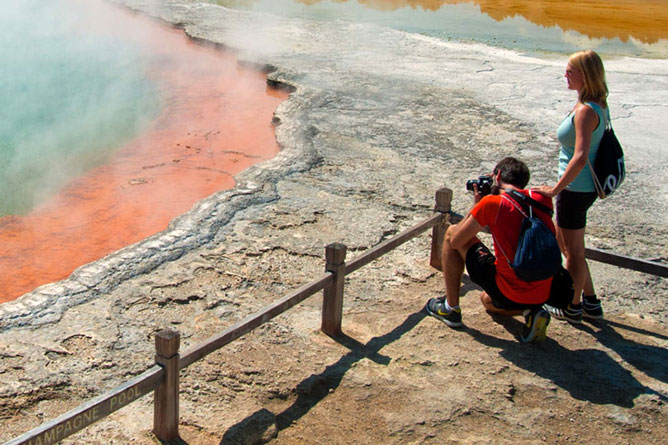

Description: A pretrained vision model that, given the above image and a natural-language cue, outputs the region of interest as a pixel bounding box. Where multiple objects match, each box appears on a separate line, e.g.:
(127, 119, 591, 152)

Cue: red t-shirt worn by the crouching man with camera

(471, 190, 555, 304)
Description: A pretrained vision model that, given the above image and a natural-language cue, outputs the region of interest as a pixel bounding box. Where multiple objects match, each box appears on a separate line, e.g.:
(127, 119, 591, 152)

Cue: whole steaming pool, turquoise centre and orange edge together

(0, 0, 286, 302)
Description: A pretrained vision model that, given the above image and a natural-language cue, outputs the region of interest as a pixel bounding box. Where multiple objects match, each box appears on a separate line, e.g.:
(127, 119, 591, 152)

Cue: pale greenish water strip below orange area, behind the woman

(209, 0, 668, 58)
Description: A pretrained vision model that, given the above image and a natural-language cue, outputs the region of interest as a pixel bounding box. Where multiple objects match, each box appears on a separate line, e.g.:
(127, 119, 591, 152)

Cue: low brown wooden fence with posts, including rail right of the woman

(6, 188, 668, 445)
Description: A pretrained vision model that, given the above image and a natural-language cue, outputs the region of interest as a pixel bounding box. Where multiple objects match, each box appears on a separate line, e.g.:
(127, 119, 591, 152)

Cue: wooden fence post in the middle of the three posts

(321, 243, 346, 336)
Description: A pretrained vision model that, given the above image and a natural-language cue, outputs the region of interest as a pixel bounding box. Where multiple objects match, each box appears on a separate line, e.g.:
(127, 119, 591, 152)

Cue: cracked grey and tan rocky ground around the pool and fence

(0, 1, 668, 444)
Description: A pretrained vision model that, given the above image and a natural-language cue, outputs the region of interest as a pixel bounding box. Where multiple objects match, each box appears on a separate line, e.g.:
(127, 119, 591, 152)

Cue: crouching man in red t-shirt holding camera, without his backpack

(426, 157, 573, 342)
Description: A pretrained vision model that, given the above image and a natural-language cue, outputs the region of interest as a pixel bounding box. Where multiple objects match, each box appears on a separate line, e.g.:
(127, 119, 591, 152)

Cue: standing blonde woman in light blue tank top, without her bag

(539, 50, 610, 323)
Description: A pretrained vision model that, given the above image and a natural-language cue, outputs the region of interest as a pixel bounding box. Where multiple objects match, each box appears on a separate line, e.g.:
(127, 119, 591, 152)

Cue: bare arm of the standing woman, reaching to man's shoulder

(538, 104, 598, 198)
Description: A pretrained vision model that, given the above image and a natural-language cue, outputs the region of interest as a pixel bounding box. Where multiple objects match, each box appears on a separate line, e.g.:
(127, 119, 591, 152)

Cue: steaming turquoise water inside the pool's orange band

(0, 0, 160, 216)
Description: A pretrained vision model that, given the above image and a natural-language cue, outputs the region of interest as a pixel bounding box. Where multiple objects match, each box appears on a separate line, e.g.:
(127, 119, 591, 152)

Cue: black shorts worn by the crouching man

(466, 243, 573, 310)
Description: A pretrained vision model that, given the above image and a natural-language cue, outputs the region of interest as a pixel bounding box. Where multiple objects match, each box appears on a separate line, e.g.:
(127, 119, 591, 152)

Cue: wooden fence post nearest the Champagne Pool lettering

(153, 330, 181, 441)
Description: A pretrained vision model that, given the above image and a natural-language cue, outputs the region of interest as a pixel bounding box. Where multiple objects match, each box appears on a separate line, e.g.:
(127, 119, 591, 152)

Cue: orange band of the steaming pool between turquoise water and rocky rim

(0, 0, 287, 302)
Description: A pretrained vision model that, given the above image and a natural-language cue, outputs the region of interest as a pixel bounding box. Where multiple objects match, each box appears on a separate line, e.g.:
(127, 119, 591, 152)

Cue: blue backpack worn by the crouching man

(497, 189, 561, 281)
